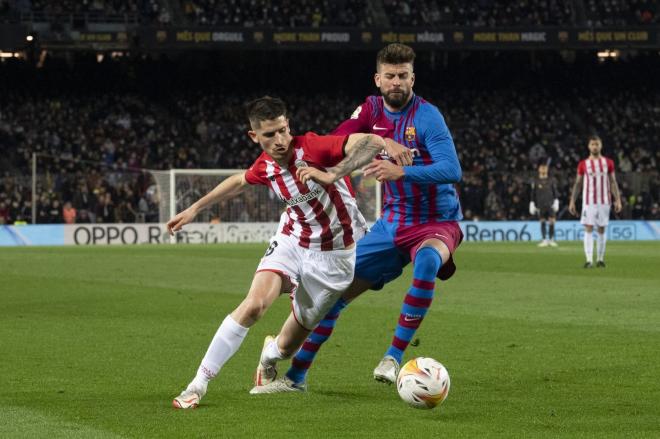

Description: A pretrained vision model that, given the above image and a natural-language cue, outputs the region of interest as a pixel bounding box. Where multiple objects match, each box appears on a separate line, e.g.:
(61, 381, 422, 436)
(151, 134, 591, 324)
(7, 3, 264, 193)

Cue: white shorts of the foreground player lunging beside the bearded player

(257, 233, 355, 331)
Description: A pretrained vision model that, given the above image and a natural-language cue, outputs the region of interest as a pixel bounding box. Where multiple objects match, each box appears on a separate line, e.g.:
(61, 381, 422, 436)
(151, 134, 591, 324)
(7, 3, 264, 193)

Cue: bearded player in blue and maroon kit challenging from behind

(252, 44, 463, 393)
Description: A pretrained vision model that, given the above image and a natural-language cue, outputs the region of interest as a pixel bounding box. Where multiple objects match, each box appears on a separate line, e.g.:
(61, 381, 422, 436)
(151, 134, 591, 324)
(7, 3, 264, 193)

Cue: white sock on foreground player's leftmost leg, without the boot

(188, 316, 249, 388)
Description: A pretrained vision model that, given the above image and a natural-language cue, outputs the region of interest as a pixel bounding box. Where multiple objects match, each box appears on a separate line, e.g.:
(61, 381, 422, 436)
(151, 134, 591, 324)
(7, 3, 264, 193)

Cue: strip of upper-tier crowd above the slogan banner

(0, 0, 659, 27)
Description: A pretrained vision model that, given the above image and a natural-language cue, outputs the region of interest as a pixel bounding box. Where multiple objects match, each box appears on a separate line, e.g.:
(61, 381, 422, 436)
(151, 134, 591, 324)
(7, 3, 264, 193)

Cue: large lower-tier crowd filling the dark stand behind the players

(0, 53, 660, 223)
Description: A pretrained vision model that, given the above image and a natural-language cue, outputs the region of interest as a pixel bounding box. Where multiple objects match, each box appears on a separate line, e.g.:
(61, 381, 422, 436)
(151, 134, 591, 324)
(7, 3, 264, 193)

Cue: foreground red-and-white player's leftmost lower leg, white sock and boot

(172, 316, 248, 409)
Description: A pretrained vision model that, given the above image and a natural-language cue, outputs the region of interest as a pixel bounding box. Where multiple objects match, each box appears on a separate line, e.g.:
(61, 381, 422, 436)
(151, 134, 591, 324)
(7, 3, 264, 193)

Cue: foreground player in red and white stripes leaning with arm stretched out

(167, 96, 385, 409)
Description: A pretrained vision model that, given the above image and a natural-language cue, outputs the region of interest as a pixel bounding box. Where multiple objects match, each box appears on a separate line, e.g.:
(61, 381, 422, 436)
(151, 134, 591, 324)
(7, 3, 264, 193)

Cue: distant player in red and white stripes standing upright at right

(568, 135, 621, 268)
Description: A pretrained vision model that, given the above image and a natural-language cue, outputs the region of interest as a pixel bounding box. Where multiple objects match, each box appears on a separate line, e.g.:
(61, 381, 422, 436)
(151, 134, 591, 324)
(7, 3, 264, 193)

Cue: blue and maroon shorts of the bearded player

(355, 219, 463, 290)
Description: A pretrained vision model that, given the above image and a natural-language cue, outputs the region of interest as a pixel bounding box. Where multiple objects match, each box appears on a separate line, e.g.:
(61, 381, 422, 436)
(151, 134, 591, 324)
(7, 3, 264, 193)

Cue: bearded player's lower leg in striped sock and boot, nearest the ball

(374, 247, 442, 383)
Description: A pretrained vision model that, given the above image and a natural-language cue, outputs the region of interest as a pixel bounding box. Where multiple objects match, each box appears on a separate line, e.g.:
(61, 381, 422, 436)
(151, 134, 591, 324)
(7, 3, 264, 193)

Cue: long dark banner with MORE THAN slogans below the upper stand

(139, 27, 660, 50)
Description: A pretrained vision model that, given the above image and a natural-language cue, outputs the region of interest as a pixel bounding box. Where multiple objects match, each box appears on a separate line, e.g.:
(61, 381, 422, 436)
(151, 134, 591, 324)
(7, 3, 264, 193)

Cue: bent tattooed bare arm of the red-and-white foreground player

(298, 134, 385, 184)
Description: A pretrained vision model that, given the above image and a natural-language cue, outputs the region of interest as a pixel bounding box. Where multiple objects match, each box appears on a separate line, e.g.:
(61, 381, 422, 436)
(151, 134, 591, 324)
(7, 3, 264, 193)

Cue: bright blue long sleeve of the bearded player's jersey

(403, 104, 462, 184)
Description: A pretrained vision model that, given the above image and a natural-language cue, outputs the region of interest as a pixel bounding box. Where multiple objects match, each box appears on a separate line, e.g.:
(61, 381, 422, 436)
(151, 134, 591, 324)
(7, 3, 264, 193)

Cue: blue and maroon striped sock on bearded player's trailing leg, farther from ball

(286, 298, 348, 385)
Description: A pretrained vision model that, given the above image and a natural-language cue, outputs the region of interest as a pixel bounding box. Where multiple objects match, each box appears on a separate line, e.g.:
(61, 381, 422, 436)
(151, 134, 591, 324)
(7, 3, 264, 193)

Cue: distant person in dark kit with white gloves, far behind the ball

(529, 162, 559, 247)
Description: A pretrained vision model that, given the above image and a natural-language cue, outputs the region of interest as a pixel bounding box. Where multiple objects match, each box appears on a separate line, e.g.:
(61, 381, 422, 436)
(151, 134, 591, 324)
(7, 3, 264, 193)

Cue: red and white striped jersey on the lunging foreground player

(245, 133, 366, 251)
